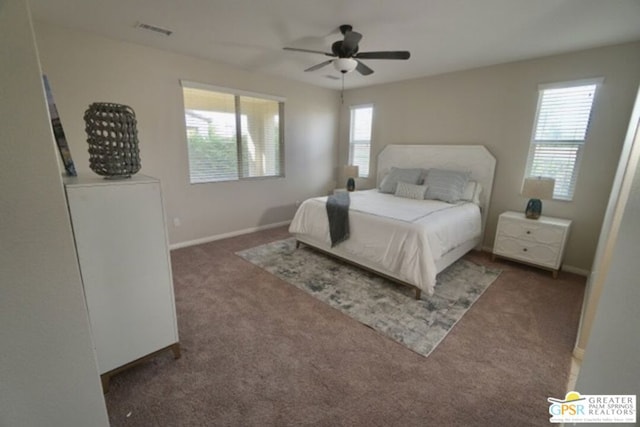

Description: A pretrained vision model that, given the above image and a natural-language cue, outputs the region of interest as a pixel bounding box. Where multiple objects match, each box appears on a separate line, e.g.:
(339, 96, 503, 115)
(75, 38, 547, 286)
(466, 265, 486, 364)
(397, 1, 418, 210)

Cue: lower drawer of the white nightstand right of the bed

(493, 235, 560, 270)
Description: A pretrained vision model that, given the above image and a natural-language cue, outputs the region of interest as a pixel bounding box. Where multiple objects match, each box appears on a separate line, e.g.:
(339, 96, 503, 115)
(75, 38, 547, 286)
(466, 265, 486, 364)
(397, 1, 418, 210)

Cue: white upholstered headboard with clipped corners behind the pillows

(376, 145, 496, 241)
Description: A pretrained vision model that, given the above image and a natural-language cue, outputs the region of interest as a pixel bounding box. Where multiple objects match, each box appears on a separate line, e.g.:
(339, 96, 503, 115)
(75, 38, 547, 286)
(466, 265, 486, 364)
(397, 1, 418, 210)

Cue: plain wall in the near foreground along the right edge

(575, 97, 640, 398)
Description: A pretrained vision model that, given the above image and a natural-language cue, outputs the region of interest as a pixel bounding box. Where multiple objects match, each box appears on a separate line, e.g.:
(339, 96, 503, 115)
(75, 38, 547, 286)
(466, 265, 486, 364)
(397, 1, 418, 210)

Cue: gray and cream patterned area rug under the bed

(237, 238, 500, 356)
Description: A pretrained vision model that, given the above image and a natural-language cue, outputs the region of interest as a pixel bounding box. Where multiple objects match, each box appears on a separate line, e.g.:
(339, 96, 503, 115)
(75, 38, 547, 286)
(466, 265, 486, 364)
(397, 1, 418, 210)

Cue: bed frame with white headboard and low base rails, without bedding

(295, 145, 496, 299)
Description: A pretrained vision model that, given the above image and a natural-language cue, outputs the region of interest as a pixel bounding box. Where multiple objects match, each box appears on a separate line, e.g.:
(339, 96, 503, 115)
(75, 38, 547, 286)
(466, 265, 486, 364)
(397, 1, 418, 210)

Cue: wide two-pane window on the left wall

(182, 81, 284, 184)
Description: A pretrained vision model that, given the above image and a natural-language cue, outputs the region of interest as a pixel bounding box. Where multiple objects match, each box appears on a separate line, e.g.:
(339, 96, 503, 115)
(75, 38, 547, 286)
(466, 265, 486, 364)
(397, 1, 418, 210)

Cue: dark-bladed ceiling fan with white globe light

(284, 25, 411, 76)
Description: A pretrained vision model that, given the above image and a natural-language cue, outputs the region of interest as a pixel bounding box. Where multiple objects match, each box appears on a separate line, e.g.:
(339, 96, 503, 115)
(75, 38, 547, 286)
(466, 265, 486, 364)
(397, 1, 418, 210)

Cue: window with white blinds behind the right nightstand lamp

(525, 79, 602, 200)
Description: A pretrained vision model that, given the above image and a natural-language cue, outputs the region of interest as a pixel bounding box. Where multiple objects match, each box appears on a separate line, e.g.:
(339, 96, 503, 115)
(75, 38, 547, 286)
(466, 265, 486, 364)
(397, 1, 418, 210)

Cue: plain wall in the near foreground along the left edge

(0, 0, 109, 427)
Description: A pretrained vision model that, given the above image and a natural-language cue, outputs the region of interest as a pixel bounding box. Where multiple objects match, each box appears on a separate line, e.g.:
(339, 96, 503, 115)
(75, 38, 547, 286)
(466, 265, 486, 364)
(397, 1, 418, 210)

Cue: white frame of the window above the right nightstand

(523, 77, 604, 201)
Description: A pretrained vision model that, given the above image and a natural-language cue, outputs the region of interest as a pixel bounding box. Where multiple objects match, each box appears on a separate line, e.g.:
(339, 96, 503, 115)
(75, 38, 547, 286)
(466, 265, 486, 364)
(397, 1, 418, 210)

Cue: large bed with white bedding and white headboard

(289, 145, 496, 299)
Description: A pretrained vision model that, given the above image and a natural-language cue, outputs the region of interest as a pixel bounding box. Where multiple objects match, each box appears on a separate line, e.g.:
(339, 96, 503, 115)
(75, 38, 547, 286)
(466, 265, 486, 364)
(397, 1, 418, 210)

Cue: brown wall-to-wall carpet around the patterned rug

(106, 227, 584, 426)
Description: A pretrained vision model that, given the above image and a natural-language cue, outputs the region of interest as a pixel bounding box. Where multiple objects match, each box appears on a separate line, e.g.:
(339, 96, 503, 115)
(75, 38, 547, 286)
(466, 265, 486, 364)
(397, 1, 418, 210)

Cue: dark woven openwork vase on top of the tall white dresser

(84, 102, 141, 179)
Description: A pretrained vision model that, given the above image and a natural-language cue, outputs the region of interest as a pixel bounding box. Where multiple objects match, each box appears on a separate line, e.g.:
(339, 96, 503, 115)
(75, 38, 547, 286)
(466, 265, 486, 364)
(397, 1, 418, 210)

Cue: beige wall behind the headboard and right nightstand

(339, 42, 640, 272)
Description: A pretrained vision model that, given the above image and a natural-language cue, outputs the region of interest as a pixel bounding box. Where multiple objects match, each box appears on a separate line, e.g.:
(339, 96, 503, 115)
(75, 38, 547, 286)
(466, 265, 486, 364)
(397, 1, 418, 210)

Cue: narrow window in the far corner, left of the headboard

(349, 105, 373, 178)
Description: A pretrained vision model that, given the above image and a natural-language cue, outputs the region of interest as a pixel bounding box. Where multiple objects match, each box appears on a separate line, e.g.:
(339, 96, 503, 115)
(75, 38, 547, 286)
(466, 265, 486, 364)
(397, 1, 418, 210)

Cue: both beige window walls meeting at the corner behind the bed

(30, 23, 640, 271)
